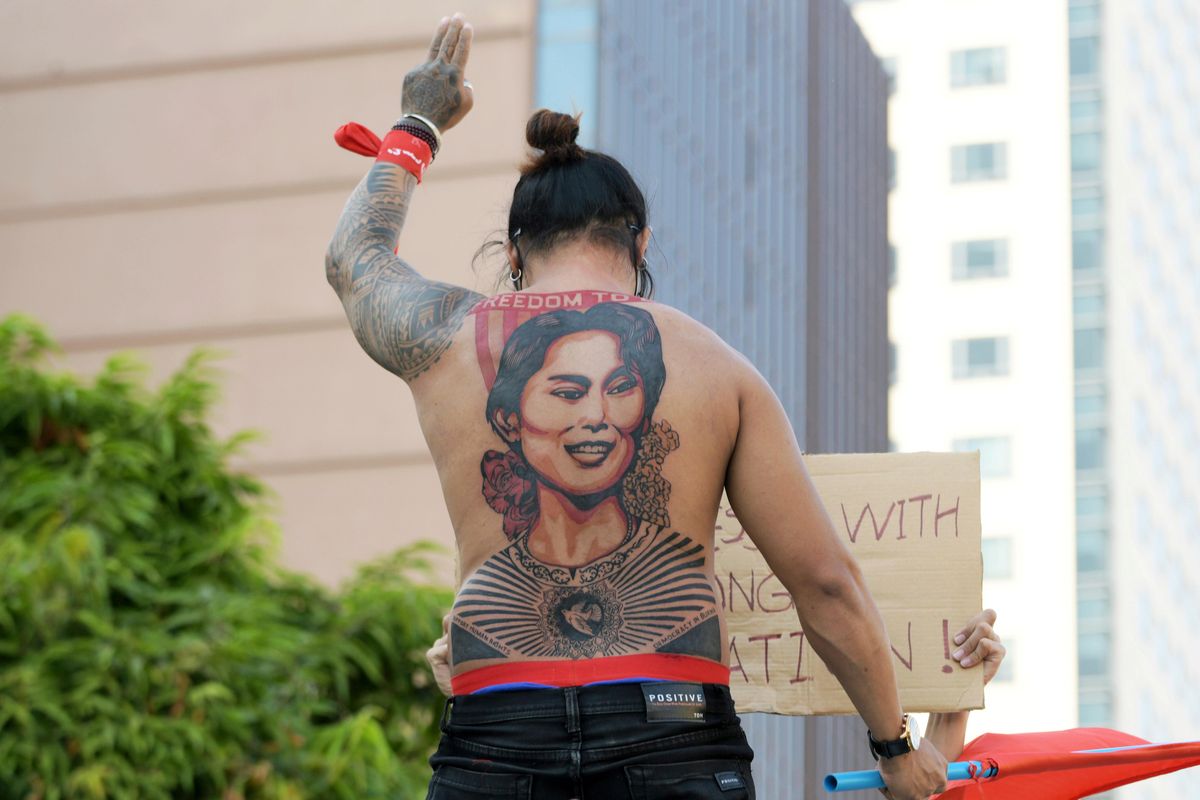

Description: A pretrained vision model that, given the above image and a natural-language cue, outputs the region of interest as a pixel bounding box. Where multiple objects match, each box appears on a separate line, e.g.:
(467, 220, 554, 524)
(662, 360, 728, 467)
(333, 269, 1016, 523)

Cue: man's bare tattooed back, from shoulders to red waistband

(413, 289, 748, 691)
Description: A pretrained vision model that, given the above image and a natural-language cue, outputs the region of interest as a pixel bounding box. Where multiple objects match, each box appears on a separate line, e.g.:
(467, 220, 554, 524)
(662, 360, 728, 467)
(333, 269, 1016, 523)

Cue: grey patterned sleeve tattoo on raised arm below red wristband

(325, 163, 481, 380)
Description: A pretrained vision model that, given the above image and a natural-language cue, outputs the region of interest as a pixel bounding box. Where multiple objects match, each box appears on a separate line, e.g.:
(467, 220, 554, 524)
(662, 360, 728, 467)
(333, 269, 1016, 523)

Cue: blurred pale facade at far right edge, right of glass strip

(1104, 0, 1200, 800)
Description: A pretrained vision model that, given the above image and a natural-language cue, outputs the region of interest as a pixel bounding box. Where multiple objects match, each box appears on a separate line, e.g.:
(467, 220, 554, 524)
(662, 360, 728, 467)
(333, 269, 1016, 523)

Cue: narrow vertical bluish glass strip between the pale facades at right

(1067, 0, 1112, 726)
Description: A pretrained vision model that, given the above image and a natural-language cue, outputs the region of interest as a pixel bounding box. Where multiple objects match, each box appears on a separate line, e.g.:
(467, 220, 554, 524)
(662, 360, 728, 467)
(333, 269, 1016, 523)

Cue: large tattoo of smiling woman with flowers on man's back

(450, 291, 722, 664)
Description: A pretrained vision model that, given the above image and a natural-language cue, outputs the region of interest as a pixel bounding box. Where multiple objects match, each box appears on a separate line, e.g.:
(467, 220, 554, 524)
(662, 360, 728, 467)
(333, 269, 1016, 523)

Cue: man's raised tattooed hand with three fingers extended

(401, 13, 475, 132)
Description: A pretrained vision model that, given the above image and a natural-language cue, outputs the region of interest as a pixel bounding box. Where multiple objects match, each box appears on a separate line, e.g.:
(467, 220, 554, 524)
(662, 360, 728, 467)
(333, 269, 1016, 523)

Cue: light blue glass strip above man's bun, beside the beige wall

(534, 0, 600, 148)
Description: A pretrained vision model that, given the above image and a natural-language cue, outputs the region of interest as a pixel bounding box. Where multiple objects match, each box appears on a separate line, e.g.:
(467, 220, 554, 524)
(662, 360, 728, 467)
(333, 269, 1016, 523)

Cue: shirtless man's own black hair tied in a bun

(506, 108, 654, 297)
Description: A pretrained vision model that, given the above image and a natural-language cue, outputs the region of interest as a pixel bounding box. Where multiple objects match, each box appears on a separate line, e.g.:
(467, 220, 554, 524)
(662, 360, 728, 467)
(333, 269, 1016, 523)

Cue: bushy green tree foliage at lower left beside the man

(0, 317, 450, 800)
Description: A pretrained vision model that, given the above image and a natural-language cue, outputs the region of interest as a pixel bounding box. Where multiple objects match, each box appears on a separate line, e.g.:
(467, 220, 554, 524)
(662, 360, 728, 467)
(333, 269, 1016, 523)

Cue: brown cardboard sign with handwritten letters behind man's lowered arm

(714, 453, 983, 715)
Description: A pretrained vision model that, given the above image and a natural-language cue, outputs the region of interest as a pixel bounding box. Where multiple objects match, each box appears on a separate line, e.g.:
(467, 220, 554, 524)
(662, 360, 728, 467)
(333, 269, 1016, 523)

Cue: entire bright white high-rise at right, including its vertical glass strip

(851, 0, 1200, 798)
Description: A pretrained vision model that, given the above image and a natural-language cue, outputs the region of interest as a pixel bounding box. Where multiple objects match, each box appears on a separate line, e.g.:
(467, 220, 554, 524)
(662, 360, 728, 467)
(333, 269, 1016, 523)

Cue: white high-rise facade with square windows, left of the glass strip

(852, 0, 1078, 733)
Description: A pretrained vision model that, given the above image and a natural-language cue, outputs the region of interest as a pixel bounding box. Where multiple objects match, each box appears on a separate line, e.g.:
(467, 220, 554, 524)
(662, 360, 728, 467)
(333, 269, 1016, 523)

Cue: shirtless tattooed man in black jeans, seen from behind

(326, 14, 946, 800)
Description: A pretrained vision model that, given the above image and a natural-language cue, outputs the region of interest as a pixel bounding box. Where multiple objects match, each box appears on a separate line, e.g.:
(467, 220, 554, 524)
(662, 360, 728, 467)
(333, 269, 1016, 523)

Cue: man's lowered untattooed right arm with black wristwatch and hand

(725, 365, 946, 800)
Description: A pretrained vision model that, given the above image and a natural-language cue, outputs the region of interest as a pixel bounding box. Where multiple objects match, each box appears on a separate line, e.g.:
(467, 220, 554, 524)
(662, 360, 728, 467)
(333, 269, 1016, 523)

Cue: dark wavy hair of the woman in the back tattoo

(486, 302, 666, 452)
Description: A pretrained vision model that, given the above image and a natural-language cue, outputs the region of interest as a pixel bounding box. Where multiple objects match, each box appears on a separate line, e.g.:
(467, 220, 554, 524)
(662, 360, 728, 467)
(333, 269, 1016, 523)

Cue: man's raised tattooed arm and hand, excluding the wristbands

(325, 14, 480, 380)
